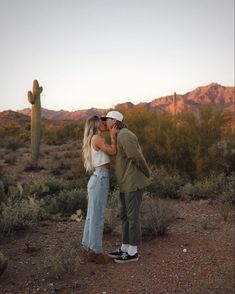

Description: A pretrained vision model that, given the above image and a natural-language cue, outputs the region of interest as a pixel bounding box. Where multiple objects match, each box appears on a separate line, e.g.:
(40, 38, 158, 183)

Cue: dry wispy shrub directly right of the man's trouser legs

(140, 196, 176, 239)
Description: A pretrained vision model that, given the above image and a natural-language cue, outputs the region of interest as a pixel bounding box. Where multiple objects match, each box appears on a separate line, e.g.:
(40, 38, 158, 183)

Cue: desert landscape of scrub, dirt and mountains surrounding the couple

(0, 83, 234, 294)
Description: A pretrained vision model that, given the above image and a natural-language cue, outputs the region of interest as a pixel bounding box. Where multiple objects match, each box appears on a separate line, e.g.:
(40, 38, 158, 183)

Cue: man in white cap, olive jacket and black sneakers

(101, 111, 150, 263)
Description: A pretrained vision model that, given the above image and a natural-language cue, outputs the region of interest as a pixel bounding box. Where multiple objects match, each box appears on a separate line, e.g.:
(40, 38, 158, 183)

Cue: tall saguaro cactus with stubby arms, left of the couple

(28, 80, 42, 161)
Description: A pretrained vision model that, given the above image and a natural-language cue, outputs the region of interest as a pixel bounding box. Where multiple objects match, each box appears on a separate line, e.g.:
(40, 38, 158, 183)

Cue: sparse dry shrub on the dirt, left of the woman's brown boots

(44, 238, 81, 278)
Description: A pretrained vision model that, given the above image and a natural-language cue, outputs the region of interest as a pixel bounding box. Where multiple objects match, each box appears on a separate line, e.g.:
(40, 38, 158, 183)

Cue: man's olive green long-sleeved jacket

(115, 128, 150, 193)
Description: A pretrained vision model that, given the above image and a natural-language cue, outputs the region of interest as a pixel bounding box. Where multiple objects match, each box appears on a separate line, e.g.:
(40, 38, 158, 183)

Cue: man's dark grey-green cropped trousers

(120, 190, 143, 246)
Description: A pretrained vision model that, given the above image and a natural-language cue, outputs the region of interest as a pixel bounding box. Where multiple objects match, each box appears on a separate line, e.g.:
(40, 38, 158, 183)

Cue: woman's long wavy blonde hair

(82, 115, 100, 172)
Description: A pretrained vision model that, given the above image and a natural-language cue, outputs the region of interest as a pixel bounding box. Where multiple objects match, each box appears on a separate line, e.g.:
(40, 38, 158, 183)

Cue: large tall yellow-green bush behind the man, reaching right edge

(116, 105, 235, 180)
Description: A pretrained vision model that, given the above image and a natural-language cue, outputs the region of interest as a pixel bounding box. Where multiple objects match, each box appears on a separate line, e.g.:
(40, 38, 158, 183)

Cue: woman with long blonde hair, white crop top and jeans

(82, 116, 117, 264)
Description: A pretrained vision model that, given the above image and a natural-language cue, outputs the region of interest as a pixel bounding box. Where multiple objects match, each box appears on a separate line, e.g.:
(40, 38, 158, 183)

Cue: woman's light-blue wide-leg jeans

(82, 167, 109, 254)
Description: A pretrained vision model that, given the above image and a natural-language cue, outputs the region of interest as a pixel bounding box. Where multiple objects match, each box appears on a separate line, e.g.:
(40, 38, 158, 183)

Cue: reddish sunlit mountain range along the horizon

(0, 83, 235, 121)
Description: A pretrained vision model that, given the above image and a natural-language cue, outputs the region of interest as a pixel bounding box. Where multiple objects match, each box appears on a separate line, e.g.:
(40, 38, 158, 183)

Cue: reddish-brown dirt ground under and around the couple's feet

(0, 201, 234, 294)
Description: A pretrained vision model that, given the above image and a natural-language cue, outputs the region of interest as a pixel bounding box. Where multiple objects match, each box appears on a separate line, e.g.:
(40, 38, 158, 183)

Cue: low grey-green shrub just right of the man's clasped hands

(148, 167, 184, 198)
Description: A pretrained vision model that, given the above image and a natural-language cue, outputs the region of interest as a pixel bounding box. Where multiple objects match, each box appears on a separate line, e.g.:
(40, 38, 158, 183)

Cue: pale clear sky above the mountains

(0, 0, 234, 111)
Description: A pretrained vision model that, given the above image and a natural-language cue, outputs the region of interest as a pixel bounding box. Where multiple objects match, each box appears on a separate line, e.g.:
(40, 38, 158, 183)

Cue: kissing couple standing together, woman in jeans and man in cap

(82, 111, 150, 264)
